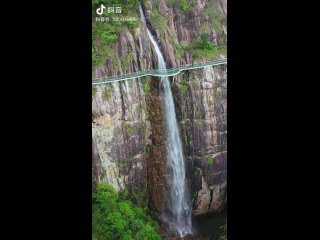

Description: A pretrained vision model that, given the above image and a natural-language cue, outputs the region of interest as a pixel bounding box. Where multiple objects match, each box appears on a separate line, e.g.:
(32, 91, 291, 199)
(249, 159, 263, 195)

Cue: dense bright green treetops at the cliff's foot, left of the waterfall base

(92, 183, 161, 240)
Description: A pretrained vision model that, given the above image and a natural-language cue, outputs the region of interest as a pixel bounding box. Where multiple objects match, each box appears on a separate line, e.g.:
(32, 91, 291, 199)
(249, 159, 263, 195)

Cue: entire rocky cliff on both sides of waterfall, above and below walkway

(92, 0, 227, 214)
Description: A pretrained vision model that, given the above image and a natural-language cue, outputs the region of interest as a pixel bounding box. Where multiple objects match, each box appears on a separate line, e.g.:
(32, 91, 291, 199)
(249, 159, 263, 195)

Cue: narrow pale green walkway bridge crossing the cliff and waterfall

(92, 59, 227, 85)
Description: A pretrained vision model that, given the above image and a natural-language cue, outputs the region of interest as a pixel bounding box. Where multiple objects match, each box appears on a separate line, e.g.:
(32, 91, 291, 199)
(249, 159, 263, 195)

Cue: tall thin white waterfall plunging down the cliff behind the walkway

(139, 5, 192, 236)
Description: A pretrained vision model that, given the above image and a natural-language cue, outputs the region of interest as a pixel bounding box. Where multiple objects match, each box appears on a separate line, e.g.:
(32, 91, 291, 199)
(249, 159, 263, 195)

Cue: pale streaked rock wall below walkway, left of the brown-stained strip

(92, 80, 150, 194)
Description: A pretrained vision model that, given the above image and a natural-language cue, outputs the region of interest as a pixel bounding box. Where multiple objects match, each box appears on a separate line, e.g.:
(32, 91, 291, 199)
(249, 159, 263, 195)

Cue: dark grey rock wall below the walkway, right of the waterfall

(174, 65, 227, 214)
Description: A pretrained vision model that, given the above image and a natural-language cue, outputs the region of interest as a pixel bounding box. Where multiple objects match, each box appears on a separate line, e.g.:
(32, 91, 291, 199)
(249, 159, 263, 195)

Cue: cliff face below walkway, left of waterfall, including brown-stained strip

(92, 76, 166, 210)
